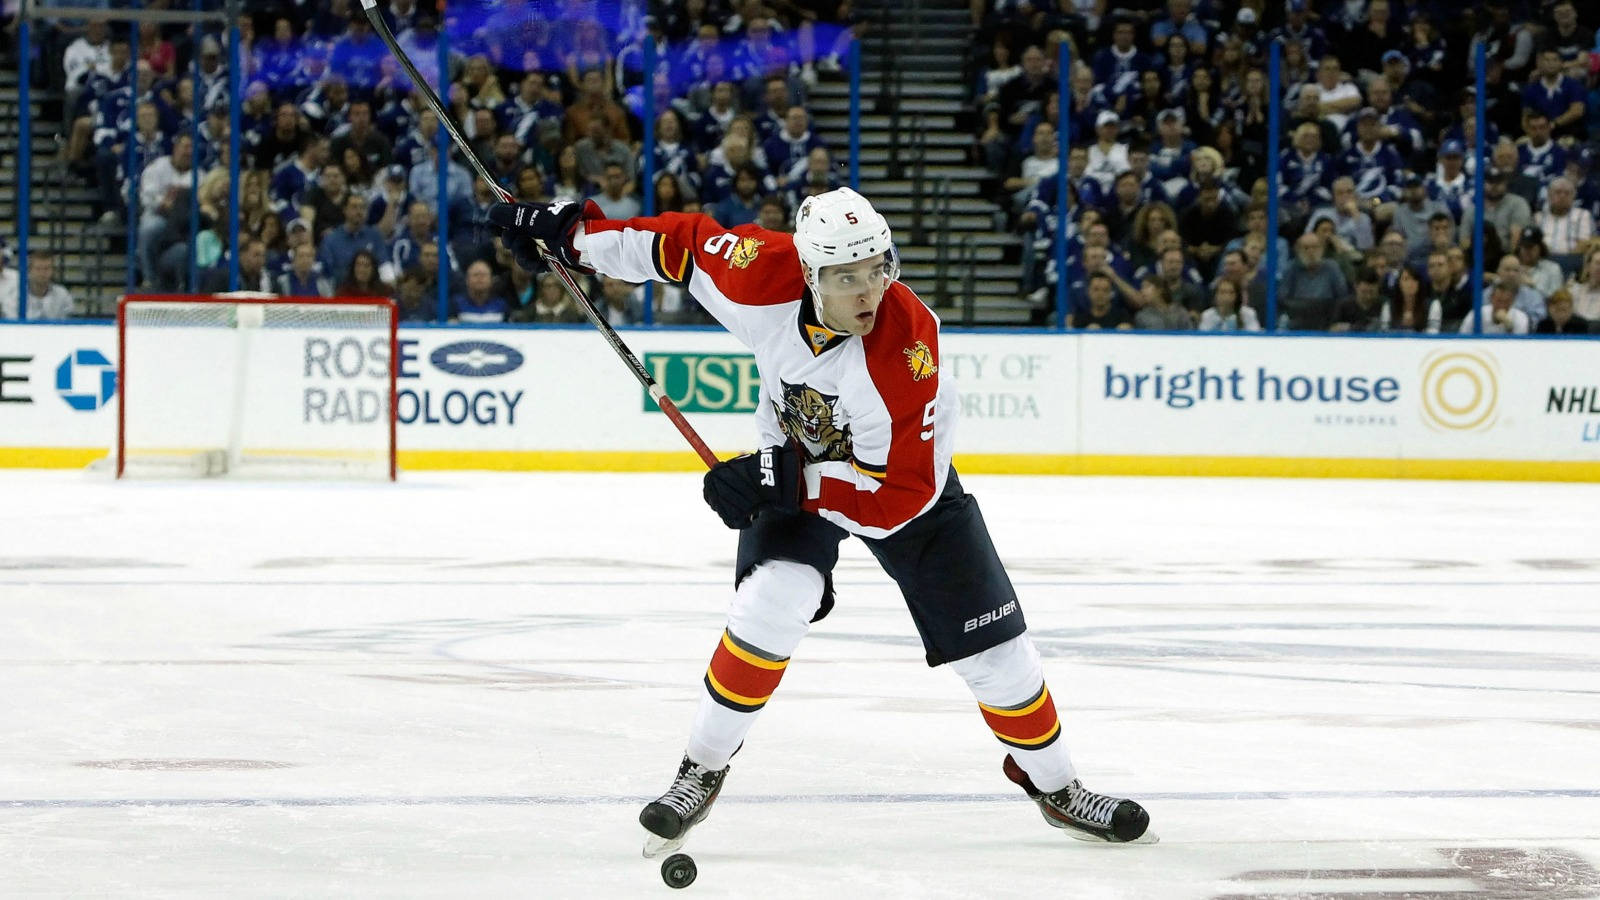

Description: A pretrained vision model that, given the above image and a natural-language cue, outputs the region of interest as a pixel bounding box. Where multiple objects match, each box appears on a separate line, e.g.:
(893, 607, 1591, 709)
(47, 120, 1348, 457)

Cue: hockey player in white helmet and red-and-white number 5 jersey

(488, 187, 1154, 855)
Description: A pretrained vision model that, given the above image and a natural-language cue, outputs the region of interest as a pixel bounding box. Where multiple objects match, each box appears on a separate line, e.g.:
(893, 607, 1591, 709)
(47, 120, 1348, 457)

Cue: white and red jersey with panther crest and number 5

(573, 205, 957, 538)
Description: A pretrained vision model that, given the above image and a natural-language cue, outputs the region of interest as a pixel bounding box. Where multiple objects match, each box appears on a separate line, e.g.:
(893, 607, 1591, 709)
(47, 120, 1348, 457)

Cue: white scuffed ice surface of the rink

(0, 471, 1600, 900)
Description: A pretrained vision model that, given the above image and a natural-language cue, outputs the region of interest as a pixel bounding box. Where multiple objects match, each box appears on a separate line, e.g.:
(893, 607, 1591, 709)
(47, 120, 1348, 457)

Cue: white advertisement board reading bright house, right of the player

(1075, 335, 1600, 463)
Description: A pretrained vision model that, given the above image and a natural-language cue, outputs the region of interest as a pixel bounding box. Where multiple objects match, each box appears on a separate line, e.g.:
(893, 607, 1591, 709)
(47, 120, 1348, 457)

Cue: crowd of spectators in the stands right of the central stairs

(971, 0, 1600, 333)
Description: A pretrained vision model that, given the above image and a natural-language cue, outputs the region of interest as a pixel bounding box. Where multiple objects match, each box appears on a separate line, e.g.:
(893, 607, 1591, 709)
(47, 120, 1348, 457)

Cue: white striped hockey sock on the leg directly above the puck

(688, 560, 824, 769)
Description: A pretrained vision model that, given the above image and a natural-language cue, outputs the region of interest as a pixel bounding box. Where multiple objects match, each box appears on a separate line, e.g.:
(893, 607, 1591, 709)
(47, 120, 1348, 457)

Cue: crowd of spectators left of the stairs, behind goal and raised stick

(30, 0, 862, 323)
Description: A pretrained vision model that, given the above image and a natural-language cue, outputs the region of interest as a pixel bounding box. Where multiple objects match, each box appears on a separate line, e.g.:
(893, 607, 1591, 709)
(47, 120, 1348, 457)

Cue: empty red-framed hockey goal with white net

(112, 293, 398, 480)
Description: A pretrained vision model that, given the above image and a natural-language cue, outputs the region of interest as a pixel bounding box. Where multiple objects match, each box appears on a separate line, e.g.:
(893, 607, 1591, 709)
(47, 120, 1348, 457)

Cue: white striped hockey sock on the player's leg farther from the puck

(950, 634, 1077, 793)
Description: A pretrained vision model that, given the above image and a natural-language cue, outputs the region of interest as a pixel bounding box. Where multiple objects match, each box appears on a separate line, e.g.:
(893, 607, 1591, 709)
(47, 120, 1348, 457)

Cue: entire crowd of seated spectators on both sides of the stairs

(12, 0, 1600, 333)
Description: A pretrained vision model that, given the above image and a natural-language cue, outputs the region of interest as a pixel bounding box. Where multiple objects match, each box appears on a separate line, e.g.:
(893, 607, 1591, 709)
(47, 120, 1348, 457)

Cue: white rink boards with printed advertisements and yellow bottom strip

(0, 323, 1600, 480)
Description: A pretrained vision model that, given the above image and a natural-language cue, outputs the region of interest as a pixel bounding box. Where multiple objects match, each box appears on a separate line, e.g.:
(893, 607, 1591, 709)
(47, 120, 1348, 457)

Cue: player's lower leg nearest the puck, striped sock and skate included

(638, 559, 827, 857)
